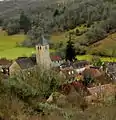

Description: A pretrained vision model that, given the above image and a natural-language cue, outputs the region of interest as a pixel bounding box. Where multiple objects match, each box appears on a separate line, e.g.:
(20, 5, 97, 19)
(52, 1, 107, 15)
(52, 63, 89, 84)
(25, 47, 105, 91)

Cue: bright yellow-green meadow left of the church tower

(0, 31, 34, 59)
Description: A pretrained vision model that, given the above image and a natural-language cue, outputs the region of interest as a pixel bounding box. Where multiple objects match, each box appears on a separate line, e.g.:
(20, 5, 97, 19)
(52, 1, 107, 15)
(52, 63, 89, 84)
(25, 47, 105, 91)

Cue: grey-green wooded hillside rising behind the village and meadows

(0, 0, 116, 57)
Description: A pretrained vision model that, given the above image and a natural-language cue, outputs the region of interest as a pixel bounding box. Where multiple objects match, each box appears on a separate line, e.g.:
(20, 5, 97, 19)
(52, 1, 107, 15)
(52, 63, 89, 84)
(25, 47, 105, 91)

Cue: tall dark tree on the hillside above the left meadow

(20, 11, 31, 34)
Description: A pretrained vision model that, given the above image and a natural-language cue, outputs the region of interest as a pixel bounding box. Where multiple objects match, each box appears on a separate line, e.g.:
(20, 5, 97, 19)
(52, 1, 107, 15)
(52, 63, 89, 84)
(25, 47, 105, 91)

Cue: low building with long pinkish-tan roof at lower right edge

(85, 84, 116, 103)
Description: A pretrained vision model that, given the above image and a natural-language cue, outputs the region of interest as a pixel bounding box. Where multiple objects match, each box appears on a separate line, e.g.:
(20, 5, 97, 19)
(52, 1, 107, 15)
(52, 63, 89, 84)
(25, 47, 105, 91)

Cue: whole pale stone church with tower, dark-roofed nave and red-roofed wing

(9, 36, 63, 75)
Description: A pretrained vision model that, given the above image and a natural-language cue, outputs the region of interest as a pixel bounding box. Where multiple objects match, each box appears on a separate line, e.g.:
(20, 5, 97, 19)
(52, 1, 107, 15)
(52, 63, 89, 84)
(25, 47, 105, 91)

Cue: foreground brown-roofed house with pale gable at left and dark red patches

(46, 81, 85, 106)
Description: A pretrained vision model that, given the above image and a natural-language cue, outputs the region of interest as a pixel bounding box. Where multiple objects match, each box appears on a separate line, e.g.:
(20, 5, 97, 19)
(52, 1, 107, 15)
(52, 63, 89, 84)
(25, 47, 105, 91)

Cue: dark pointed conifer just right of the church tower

(65, 34, 76, 61)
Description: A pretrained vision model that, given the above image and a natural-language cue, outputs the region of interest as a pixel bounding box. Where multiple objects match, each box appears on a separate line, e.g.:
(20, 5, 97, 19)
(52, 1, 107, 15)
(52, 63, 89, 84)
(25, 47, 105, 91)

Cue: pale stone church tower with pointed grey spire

(36, 36, 51, 69)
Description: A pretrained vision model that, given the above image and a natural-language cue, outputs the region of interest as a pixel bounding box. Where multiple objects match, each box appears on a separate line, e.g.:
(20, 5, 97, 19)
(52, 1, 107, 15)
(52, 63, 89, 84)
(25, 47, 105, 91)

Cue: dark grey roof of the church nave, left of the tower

(16, 57, 36, 69)
